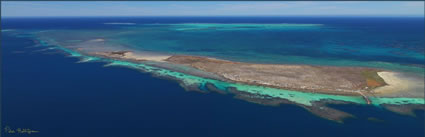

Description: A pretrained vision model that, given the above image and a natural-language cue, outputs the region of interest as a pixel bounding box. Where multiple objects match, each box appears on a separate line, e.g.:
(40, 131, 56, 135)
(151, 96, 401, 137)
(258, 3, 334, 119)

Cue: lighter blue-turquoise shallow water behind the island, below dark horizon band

(29, 23, 425, 76)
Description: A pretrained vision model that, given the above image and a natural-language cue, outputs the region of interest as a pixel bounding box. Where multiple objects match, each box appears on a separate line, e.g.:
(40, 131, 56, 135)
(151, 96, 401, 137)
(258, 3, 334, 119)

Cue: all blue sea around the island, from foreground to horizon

(1, 17, 425, 137)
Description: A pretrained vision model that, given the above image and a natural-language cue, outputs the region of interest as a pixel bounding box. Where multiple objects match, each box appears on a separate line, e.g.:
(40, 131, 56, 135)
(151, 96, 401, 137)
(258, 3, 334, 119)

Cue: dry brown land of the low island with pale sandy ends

(71, 38, 423, 97)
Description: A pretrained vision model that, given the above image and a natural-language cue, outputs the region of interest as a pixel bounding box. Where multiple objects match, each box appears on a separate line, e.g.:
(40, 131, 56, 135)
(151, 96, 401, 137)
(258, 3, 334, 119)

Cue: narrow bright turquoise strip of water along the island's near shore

(32, 37, 425, 106)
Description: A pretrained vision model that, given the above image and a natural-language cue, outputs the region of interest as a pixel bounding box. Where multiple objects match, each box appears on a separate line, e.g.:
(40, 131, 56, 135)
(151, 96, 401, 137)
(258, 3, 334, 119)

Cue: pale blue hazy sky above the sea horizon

(1, 1, 424, 17)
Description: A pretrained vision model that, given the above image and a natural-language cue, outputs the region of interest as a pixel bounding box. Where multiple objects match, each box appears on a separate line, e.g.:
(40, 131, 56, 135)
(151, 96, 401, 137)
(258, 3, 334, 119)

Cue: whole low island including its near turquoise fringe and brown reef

(37, 39, 424, 122)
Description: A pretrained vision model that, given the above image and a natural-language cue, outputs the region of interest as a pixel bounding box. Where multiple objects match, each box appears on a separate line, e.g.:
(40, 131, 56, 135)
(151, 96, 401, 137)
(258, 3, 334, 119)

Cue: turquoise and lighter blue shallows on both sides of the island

(4, 16, 424, 105)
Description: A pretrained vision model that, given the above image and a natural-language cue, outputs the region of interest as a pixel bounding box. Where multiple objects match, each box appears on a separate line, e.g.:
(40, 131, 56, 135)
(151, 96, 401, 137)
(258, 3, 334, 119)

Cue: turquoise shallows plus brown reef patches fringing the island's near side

(32, 37, 424, 123)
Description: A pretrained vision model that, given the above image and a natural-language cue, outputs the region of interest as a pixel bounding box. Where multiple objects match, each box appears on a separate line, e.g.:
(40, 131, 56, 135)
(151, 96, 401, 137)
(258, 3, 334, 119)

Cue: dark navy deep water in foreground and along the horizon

(1, 17, 424, 137)
